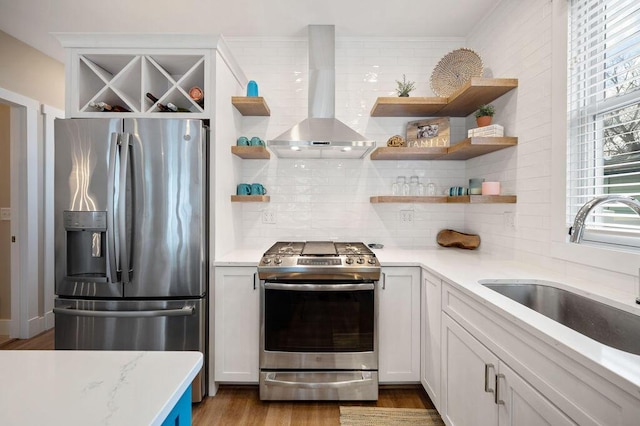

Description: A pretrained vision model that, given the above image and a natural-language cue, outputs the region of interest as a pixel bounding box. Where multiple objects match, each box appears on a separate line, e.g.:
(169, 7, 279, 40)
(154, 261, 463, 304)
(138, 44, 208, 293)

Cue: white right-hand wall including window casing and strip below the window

(466, 0, 640, 296)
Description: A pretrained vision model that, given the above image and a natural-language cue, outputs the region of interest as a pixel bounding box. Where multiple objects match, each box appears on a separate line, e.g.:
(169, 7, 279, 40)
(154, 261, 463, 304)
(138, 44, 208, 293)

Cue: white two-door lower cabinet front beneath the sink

(438, 281, 640, 426)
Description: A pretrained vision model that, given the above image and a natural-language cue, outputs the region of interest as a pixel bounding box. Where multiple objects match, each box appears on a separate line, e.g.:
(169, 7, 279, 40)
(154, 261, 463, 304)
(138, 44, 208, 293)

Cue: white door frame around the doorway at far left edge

(0, 87, 40, 339)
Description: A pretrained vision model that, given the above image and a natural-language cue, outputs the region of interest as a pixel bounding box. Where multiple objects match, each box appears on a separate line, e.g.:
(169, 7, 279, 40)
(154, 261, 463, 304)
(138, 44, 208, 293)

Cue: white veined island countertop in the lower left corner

(0, 350, 202, 426)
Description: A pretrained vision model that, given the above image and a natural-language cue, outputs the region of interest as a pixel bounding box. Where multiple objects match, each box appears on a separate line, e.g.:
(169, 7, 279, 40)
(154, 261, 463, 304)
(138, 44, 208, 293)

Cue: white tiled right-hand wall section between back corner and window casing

(466, 0, 552, 260)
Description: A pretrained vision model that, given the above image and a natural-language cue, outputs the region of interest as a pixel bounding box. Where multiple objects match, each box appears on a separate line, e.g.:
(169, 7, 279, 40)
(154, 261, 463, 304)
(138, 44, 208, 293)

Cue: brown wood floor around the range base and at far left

(0, 330, 433, 426)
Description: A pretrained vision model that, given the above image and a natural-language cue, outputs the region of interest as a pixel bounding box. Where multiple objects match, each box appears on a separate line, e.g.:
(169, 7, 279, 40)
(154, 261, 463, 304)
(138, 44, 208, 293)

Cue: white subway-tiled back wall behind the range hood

(227, 37, 466, 248)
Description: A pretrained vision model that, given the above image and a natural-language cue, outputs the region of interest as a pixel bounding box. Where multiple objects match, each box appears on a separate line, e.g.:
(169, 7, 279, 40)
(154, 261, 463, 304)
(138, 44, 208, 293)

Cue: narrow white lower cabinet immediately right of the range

(378, 267, 420, 383)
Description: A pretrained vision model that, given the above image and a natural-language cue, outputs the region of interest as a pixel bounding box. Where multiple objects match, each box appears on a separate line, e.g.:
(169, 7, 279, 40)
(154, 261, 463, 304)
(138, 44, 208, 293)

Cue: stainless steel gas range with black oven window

(258, 241, 380, 400)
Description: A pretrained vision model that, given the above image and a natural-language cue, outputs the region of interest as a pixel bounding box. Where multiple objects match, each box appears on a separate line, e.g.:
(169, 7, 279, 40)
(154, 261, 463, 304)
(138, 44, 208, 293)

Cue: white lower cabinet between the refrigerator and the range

(213, 266, 260, 383)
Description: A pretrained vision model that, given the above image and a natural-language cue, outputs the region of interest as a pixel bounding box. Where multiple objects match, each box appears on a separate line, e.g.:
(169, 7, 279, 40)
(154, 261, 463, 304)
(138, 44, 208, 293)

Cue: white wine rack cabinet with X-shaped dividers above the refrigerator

(56, 33, 246, 119)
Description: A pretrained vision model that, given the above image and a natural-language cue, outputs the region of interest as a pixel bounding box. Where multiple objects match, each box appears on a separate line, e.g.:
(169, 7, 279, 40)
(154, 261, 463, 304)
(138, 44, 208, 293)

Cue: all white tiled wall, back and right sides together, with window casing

(224, 0, 640, 301)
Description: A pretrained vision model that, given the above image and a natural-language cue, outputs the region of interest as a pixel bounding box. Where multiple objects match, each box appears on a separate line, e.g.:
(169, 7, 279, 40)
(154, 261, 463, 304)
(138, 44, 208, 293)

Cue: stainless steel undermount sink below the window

(479, 280, 640, 355)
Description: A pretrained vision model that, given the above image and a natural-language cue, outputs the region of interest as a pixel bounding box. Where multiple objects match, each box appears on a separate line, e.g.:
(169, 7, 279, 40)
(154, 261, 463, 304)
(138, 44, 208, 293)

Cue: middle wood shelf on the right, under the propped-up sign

(371, 136, 518, 160)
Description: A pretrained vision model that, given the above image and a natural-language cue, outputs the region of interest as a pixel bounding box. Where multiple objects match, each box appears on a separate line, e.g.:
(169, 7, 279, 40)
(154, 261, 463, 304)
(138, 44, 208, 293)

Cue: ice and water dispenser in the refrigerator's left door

(63, 211, 107, 282)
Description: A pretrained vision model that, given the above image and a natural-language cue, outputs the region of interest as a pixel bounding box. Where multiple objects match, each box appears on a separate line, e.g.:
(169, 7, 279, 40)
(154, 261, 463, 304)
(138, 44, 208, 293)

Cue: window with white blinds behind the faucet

(567, 0, 640, 248)
